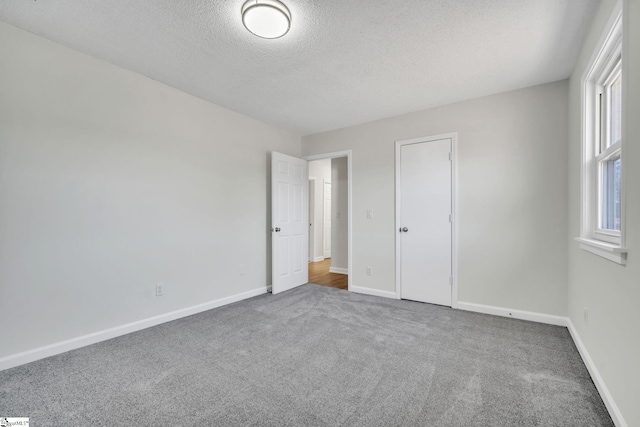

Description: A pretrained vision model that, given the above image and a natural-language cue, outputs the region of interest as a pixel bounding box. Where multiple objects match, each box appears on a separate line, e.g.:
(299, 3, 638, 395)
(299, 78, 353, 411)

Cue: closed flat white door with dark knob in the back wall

(397, 139, 452, 306)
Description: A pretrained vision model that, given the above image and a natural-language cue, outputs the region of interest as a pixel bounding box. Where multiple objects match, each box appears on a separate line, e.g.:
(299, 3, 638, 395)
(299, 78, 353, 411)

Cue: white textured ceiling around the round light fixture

(0, 0, 599, 135)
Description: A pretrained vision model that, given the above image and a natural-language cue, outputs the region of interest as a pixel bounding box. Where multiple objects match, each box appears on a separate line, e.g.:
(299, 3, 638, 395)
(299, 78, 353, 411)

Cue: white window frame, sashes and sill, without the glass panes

(576, 1, 627, 265)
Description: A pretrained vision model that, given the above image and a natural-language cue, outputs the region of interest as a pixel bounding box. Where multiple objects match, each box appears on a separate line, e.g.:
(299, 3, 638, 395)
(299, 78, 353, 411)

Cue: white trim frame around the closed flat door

(395, 132, 458, 308)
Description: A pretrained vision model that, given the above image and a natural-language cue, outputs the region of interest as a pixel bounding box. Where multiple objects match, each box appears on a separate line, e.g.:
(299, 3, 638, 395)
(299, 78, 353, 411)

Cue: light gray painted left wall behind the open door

(0, 23, 300, 357)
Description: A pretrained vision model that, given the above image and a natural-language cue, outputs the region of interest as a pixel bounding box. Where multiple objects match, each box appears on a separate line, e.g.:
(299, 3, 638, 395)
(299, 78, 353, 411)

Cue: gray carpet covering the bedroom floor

(0, 285, 613, 427)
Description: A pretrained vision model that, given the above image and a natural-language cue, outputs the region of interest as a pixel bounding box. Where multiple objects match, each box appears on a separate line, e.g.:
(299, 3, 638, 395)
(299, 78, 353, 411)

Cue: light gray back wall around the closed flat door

(302, 81, 568, 315)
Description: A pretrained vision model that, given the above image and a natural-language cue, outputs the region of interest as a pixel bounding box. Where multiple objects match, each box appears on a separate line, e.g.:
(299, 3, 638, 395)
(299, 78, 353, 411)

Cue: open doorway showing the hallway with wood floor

(305, 150, 351, 289)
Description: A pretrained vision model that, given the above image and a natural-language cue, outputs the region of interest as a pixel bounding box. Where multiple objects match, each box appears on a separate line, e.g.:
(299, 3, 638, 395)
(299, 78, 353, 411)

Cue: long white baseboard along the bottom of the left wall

(0, 286, 267, 371)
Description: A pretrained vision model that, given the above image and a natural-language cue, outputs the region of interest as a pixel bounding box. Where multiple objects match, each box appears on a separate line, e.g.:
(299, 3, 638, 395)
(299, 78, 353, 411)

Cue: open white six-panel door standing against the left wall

(271, 151, 309, 294)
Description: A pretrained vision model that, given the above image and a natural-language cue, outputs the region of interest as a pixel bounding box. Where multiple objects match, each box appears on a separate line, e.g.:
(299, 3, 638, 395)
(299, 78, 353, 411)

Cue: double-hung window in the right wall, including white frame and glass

(577, 6, 626, 264)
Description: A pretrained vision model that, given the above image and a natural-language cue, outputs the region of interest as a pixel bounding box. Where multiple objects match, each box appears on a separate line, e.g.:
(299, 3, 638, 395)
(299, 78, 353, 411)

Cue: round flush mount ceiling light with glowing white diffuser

(242, 0, 291, 39)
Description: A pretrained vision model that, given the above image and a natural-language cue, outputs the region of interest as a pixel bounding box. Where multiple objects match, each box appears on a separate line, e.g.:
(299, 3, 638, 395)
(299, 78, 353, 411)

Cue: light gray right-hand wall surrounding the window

(568, 0, 640, 426)
